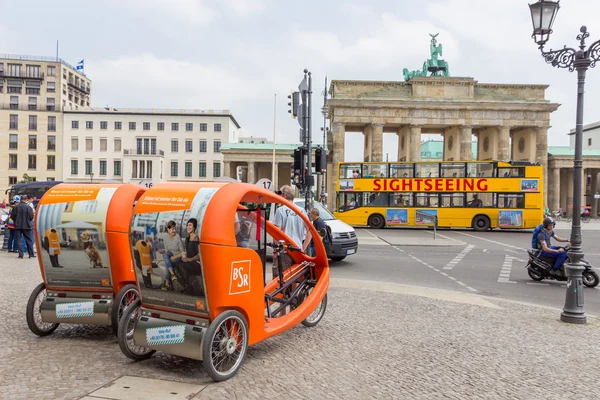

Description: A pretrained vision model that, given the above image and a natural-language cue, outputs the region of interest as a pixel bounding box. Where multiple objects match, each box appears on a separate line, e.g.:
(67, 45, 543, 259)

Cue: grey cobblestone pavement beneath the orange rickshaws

(0, 252, 600, 399)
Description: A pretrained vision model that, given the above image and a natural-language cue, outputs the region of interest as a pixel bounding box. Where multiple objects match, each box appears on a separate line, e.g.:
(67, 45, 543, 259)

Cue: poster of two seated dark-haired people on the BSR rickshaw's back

(131, 188, 218, 312)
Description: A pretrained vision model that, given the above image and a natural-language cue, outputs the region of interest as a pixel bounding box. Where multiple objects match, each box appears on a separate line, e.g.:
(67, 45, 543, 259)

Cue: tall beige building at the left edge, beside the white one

(0, 54, 91, 191)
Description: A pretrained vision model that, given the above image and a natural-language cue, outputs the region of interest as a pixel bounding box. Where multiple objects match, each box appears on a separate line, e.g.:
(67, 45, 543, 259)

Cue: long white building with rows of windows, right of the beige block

(62, 108, 240, 183)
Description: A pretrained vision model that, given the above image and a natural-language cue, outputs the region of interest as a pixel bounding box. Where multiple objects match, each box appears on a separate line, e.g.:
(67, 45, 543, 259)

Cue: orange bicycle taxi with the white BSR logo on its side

(118, 182, 329, 381)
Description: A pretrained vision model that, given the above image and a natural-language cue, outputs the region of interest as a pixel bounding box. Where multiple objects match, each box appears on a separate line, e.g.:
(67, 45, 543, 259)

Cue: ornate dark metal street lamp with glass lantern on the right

(529, 0, 600, 324)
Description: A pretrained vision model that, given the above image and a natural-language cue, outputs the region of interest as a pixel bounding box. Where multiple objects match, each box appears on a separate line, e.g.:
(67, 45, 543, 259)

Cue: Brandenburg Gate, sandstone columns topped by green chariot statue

(327, 36, 559, 210)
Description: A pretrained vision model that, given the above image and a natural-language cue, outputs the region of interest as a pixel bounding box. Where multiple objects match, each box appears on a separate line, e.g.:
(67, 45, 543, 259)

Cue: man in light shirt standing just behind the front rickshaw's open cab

(273, 185, 312, 277)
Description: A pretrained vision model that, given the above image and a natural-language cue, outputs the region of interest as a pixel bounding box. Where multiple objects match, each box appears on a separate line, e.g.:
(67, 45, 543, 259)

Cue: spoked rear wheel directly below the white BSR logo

(202, 310, 248, 382)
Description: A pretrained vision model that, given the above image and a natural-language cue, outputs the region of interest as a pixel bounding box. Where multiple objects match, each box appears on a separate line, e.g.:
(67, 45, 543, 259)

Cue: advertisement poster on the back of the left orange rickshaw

(36, 188, 116, 287)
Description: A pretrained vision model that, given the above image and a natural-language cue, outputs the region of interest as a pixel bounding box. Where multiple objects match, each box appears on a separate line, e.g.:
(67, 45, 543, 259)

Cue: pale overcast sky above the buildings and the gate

(0, 0, 600, 161)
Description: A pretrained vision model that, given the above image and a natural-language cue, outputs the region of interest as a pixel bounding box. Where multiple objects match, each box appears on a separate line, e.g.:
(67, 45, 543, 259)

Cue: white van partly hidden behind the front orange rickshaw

(267, 197, 358, 261)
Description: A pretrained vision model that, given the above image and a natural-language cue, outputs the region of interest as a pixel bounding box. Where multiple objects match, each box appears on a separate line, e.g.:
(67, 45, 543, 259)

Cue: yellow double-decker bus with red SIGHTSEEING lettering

(334, 161, 544, 231)
